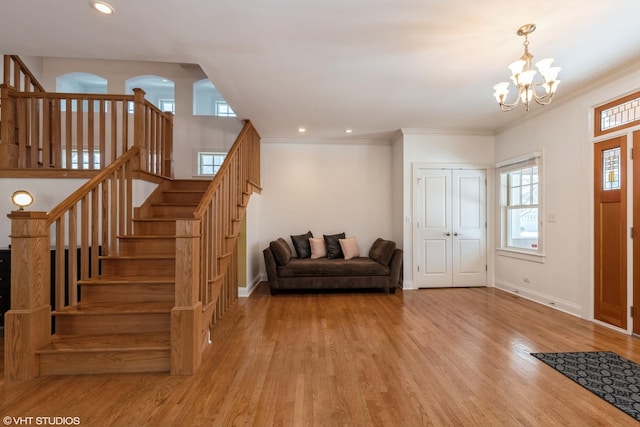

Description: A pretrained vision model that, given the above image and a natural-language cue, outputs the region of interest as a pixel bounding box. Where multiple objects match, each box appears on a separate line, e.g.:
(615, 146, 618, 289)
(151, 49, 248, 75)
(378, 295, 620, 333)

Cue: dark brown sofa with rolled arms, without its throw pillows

(263, 238, 402, 294)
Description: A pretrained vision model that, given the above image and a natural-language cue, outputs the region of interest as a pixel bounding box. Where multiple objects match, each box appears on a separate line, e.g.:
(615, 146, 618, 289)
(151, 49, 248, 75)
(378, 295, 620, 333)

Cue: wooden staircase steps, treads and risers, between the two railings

(36, 180, 210, 375)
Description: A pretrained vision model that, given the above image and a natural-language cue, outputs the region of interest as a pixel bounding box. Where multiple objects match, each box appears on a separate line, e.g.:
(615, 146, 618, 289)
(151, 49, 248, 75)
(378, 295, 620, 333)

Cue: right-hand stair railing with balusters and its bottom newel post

(171, 121, 260, 374)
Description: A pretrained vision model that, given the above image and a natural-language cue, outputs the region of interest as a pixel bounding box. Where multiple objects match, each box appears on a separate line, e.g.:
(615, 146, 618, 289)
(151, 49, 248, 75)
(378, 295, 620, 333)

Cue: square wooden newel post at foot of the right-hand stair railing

(171, 219, 203, 375)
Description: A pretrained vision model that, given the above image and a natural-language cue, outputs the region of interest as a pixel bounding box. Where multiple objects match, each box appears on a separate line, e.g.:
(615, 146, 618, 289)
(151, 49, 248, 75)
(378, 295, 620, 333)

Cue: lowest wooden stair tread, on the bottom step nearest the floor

(37, 332, 170, 354)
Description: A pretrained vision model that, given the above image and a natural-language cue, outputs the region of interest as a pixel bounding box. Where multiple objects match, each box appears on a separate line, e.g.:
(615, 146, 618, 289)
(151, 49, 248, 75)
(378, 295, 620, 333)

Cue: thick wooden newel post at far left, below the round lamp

(4, 211, 51, 382)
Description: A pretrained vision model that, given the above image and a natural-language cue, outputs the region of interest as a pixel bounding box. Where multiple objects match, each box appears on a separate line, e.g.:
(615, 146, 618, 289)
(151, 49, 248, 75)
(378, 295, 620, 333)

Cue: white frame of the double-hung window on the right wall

(496, 152, 545, 263)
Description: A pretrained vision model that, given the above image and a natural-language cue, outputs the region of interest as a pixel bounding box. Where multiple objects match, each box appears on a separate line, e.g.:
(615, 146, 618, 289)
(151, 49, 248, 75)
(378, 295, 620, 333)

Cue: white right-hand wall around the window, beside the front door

(495, 67, 640, 323)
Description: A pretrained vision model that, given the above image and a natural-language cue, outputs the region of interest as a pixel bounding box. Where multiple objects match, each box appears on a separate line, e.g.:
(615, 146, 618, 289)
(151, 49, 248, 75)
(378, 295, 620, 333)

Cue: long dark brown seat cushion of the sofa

(278, 257, 389, 277)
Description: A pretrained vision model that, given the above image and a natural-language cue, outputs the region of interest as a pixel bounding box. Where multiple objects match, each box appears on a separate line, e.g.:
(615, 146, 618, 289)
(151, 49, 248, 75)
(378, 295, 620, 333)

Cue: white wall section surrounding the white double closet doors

(396, 130, 494, 289)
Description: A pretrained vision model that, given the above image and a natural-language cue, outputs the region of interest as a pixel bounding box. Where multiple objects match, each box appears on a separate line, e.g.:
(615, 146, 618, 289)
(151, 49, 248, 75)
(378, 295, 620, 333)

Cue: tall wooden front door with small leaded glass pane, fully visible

(594, 136, 627, 329)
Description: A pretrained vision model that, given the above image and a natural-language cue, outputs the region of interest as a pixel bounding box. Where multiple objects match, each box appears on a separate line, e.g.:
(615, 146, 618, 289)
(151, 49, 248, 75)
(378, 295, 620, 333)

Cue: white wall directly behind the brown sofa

(258, 141, 393, 280)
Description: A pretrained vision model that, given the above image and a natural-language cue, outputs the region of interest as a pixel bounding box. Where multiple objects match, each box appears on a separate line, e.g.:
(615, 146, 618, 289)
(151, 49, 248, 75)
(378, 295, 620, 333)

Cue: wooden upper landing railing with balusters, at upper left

(0, 55, 173, 178)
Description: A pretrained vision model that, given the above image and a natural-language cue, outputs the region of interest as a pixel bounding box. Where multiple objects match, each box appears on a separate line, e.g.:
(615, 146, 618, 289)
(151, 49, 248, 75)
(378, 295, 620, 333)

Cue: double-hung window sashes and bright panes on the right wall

(498, 154, 542, 253)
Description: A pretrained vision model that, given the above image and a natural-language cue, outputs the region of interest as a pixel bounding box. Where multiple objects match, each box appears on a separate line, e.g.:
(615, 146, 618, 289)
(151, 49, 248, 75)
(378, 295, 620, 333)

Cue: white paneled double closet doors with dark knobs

(413, 168, 487, 288)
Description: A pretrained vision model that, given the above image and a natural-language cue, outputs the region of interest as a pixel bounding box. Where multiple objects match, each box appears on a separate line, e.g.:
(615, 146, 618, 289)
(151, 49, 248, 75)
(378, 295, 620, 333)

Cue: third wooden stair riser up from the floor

(81, 283, 175, 304)
